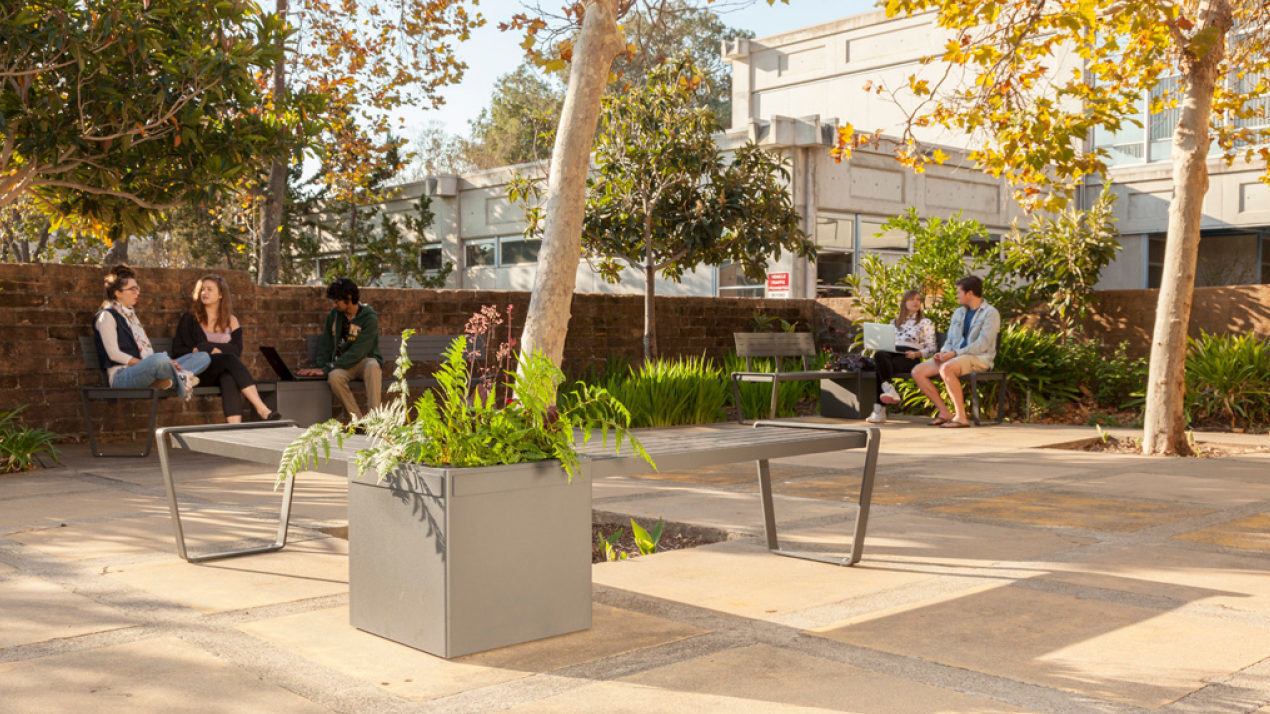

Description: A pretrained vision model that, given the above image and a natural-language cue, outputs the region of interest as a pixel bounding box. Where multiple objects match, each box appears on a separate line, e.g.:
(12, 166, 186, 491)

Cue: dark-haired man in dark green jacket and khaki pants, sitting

(300, 273, 384, 417)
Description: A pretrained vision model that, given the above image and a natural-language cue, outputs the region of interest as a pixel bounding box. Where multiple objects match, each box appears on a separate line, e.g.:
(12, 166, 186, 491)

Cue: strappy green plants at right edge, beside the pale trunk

(1186, 333, 1270, 428)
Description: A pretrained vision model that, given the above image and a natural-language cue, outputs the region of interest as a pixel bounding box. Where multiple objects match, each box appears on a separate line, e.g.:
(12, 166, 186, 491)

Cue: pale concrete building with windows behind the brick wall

(342, 6, 1270, 297)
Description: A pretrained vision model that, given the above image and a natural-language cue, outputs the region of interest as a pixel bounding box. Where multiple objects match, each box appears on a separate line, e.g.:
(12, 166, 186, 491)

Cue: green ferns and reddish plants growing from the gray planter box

(278, 306, 653, 482)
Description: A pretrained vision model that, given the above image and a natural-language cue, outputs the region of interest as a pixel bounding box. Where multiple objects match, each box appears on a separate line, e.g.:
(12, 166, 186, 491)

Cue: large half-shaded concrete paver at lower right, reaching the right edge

(818, 586, 1270, 708)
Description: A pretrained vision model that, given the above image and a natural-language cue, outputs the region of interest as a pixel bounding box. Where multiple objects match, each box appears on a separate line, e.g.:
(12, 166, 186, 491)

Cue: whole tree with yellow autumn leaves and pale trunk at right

(837, 0, 1270, 454)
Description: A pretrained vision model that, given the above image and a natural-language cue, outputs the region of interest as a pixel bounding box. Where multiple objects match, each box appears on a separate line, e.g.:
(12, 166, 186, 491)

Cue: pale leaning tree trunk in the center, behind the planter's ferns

(521, 0, 625, 365)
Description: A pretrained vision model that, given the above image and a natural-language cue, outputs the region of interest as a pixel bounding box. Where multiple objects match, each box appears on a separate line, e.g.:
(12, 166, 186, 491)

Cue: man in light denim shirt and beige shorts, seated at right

(912, 276, 1001, 428)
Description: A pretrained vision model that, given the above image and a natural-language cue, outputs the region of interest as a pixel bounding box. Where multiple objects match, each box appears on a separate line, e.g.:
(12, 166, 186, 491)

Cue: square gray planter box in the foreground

(348, 460, 591, 657)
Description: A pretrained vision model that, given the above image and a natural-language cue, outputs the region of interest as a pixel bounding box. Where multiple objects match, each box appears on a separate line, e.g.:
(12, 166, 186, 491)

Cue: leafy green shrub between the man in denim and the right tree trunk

(997, 183, 1120, 334)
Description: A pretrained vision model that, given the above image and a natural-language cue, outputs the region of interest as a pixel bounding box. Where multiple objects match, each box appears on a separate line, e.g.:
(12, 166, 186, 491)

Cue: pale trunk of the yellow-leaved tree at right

(1142, 0, 1232, 455)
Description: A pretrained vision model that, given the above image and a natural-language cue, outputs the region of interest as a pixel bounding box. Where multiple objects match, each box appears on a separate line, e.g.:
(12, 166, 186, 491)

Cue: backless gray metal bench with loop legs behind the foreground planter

(156, 421, 881, 565)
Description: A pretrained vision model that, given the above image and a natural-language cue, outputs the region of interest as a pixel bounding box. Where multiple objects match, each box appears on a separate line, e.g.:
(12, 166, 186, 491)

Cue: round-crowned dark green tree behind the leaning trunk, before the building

(509, 56, 814, 360)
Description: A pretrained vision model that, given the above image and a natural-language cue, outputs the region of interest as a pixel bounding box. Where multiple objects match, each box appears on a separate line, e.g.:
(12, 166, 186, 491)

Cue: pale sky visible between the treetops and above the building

(401, 0, 875, 138)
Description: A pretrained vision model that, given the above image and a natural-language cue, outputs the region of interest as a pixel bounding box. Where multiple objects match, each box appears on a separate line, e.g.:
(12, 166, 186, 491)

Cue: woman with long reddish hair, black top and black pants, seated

(171, 269, 282, 424)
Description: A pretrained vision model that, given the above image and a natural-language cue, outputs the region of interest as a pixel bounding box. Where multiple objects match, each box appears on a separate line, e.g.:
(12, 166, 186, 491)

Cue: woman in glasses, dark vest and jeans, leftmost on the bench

(93, 264, 211, 399)
